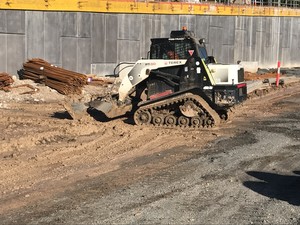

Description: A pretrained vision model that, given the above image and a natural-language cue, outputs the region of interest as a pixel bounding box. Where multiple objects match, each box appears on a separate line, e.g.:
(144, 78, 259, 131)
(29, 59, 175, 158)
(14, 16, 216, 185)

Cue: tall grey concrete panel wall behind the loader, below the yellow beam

(0, 10, 300, 75)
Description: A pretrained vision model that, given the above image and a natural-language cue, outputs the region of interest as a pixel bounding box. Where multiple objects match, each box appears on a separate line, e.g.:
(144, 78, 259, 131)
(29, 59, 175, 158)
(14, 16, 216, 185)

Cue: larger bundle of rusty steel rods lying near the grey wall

(22, 59, 87, 95)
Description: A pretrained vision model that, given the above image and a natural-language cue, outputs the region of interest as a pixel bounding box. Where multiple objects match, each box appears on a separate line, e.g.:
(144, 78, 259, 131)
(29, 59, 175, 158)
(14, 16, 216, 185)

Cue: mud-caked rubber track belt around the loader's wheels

(134, 93, 221, 128)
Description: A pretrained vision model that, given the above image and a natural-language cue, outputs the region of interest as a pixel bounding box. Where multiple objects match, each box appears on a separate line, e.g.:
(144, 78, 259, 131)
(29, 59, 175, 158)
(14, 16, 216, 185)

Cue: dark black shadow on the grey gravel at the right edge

(243, 171, 300, 206)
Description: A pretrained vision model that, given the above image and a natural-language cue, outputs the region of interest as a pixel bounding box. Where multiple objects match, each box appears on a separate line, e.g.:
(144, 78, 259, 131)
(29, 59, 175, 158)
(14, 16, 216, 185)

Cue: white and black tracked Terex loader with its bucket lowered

(68, 29, 247, 128)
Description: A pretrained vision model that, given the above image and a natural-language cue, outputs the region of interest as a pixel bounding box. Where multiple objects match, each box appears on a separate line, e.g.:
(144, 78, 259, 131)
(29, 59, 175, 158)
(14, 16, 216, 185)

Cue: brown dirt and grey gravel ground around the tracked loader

(0, 74, 300, 224)
